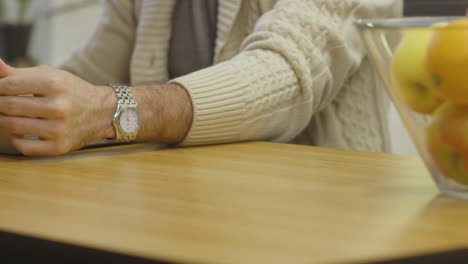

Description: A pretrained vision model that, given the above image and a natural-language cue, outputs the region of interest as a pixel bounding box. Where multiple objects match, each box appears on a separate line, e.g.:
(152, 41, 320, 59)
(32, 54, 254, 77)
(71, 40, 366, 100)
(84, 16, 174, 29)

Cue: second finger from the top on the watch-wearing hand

(0, 96, 67, 120)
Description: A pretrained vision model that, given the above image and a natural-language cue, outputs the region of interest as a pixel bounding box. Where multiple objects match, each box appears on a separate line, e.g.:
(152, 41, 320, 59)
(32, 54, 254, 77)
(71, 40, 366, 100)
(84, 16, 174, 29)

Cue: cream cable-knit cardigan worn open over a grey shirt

(63, 0, 402, 151)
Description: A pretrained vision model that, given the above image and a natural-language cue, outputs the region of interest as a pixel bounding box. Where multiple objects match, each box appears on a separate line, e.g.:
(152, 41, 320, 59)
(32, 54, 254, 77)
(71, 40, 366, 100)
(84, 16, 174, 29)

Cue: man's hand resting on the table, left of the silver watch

(0, 61, 116, 156)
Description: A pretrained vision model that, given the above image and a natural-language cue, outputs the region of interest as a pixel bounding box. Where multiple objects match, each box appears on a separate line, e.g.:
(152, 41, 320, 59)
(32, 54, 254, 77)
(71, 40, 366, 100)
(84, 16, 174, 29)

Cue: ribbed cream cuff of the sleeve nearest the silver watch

(170, 62, 247, 146)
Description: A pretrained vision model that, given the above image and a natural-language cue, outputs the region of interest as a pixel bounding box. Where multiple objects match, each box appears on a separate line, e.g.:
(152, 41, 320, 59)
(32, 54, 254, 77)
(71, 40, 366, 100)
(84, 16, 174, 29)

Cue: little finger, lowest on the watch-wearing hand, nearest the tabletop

(11, 135, 67, 156)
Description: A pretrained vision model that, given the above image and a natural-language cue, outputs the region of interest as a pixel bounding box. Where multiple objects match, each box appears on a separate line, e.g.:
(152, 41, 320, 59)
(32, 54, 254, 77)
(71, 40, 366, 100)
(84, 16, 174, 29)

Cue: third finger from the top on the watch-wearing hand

(0, 115, 65, 139)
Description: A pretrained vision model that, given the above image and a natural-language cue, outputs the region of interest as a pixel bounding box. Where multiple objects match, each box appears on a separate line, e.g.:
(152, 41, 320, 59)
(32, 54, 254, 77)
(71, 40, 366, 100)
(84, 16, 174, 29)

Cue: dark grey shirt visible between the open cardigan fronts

(167, 0, 218, 78)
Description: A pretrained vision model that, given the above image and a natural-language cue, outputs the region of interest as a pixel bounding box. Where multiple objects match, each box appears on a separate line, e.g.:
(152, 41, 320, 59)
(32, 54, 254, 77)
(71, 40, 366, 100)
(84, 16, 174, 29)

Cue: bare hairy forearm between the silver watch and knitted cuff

(99, 84, 193, 143)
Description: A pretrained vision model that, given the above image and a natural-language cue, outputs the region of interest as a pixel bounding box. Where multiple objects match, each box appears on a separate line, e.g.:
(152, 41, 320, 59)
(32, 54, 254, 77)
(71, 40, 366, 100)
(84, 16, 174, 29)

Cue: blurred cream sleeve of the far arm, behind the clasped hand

(60, 0, 136, 85)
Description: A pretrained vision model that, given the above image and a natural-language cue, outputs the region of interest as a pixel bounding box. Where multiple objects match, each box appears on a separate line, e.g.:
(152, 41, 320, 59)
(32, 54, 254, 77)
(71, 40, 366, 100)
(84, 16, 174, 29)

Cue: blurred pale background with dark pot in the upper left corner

(0, 0, 102, 66)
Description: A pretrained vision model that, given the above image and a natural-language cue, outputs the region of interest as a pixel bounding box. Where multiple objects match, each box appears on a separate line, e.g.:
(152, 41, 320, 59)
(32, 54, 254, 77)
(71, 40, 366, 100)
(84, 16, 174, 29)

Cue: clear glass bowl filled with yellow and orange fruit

(357, 17, 468, 199)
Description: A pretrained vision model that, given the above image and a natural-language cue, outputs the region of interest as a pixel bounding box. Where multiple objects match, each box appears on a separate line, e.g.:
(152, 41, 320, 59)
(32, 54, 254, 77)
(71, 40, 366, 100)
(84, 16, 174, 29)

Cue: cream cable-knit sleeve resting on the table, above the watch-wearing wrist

(174, 0, 401, 145)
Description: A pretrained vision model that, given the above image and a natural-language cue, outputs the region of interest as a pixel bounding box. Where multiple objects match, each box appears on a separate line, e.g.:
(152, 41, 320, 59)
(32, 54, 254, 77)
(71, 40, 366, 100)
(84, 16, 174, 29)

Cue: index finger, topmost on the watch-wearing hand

(0, 71, 63, 96)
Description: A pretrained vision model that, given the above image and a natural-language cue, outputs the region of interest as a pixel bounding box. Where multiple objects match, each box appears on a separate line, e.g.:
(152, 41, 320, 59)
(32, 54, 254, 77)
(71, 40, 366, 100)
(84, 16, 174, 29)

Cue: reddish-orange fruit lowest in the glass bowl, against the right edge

(426, 103, 468, 185)
